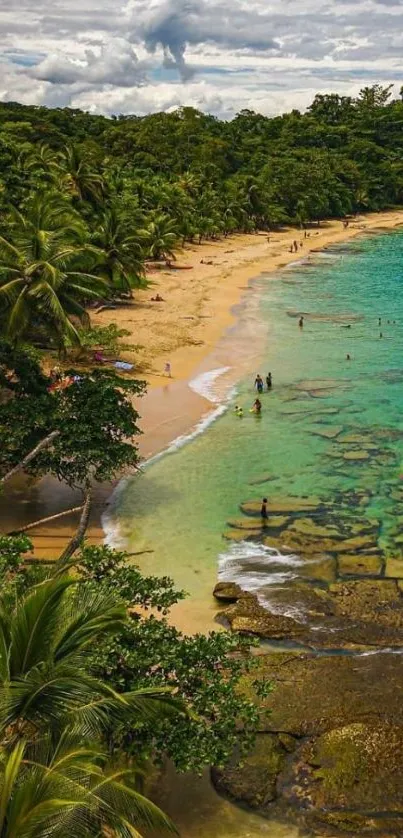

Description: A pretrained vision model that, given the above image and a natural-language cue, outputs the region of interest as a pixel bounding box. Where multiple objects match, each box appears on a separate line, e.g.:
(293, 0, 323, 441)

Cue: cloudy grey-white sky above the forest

(0, 0, 403, 118)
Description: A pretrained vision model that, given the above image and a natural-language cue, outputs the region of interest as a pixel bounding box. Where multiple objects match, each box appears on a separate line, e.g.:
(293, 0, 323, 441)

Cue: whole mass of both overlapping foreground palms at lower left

(0, 568, 185, 838)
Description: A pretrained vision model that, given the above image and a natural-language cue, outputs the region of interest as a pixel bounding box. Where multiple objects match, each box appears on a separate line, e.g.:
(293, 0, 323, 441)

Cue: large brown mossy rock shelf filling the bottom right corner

(212, 651, 403, 838)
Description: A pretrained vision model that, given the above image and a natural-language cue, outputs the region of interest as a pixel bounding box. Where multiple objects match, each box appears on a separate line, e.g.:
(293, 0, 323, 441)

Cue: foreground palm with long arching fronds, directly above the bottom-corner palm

(0, 576, 184, 740)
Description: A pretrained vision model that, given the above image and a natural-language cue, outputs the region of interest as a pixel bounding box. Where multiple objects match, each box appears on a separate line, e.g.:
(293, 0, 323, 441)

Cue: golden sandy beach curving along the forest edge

(0, 211, 403, 558)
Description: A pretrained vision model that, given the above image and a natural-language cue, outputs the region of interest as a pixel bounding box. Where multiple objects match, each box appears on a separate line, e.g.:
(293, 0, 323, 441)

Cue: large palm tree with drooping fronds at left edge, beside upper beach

(0, 194, 107, 347)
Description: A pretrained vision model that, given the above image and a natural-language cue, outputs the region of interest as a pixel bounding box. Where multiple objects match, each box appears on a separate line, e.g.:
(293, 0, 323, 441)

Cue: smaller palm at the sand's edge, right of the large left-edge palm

(93, 206, 146, 295)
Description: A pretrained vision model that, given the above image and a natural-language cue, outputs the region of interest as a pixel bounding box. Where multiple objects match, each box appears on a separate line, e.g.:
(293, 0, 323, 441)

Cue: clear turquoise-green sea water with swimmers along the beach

(112, 232, 403, 838)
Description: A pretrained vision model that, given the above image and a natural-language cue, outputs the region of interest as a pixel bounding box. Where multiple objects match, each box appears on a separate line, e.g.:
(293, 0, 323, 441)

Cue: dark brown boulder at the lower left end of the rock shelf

(212, 733, 288, 810)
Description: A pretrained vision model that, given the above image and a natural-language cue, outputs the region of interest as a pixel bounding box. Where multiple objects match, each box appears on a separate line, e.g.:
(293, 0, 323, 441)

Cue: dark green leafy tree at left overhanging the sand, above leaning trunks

(0, 344, 145, 486)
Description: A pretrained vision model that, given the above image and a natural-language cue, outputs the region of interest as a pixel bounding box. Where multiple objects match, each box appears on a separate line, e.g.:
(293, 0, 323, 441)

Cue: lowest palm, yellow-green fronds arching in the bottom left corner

(0, 731, 177, 838)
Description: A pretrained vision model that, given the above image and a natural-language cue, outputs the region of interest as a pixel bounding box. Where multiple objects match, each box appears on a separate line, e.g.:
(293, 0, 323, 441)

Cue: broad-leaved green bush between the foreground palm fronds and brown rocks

(79, 547, 269, 771)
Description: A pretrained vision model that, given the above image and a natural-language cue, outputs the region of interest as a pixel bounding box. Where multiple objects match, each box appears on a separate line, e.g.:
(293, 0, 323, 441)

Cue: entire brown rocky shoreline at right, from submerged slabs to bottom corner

(212, 476, 403, 838)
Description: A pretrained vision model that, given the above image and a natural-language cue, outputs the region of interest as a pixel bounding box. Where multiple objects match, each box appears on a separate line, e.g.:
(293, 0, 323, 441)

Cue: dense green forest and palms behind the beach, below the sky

(0, 84, 403, 351)
